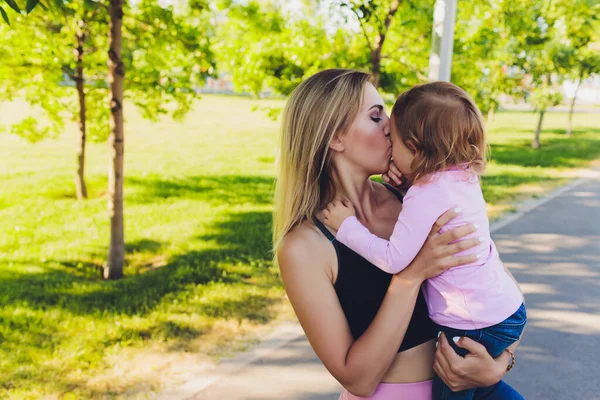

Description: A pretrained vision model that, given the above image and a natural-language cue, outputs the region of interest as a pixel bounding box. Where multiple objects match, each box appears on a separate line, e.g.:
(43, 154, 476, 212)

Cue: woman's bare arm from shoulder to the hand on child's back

(278, 212, 479, 397)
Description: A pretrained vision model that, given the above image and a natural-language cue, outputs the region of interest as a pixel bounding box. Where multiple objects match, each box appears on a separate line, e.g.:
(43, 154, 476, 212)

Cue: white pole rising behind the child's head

(429, 0, 457, 82)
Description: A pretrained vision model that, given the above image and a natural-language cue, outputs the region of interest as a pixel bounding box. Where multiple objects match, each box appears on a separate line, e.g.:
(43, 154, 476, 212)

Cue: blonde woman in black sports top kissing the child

(273, 69, 511, 400)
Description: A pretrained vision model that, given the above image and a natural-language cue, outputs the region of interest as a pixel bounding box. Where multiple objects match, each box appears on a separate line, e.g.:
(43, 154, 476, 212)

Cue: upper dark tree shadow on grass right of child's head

(491, 129, 600, 167)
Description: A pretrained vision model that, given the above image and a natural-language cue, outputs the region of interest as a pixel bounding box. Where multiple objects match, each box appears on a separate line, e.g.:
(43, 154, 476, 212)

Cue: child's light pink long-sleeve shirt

(337, 167, 523, 330)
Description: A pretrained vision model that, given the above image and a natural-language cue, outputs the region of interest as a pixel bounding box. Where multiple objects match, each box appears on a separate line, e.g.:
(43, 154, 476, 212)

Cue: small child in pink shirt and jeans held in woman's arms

(324, 82, 527, 400)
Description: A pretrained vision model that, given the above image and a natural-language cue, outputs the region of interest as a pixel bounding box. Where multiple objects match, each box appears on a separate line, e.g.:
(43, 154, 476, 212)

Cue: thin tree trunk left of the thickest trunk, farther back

(75, 22, 87, 200)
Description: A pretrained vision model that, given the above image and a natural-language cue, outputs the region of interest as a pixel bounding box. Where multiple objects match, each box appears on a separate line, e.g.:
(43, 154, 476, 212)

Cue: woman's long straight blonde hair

(273, 69, 369, 256)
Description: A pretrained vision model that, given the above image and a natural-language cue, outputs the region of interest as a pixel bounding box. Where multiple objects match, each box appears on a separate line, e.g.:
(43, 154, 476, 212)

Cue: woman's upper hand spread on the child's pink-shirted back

(400, 209, 481, 281)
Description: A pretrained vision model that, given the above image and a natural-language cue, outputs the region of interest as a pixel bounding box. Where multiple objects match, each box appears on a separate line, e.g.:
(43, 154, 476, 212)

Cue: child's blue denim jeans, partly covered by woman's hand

(433, 304, 527, 400)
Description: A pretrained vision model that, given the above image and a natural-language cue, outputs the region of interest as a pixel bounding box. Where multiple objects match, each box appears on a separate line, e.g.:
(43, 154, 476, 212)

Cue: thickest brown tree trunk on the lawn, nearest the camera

(104, 0, 125, 279)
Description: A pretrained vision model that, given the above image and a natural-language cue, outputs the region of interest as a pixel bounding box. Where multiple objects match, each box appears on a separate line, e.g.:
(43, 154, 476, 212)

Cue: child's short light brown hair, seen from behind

(392, 82, 486, 183)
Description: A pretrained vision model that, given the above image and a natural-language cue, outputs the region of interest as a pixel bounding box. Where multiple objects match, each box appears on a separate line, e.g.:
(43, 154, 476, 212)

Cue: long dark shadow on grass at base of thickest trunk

(0, 212, 271, 315)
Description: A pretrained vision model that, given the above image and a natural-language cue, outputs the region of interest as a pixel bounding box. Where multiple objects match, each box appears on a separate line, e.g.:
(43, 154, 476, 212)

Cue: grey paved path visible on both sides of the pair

(161, 173, 600, 400)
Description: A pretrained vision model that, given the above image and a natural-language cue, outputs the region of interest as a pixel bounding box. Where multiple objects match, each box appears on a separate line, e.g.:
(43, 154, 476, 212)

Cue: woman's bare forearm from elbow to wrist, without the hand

(342, 270, 422, 397)
